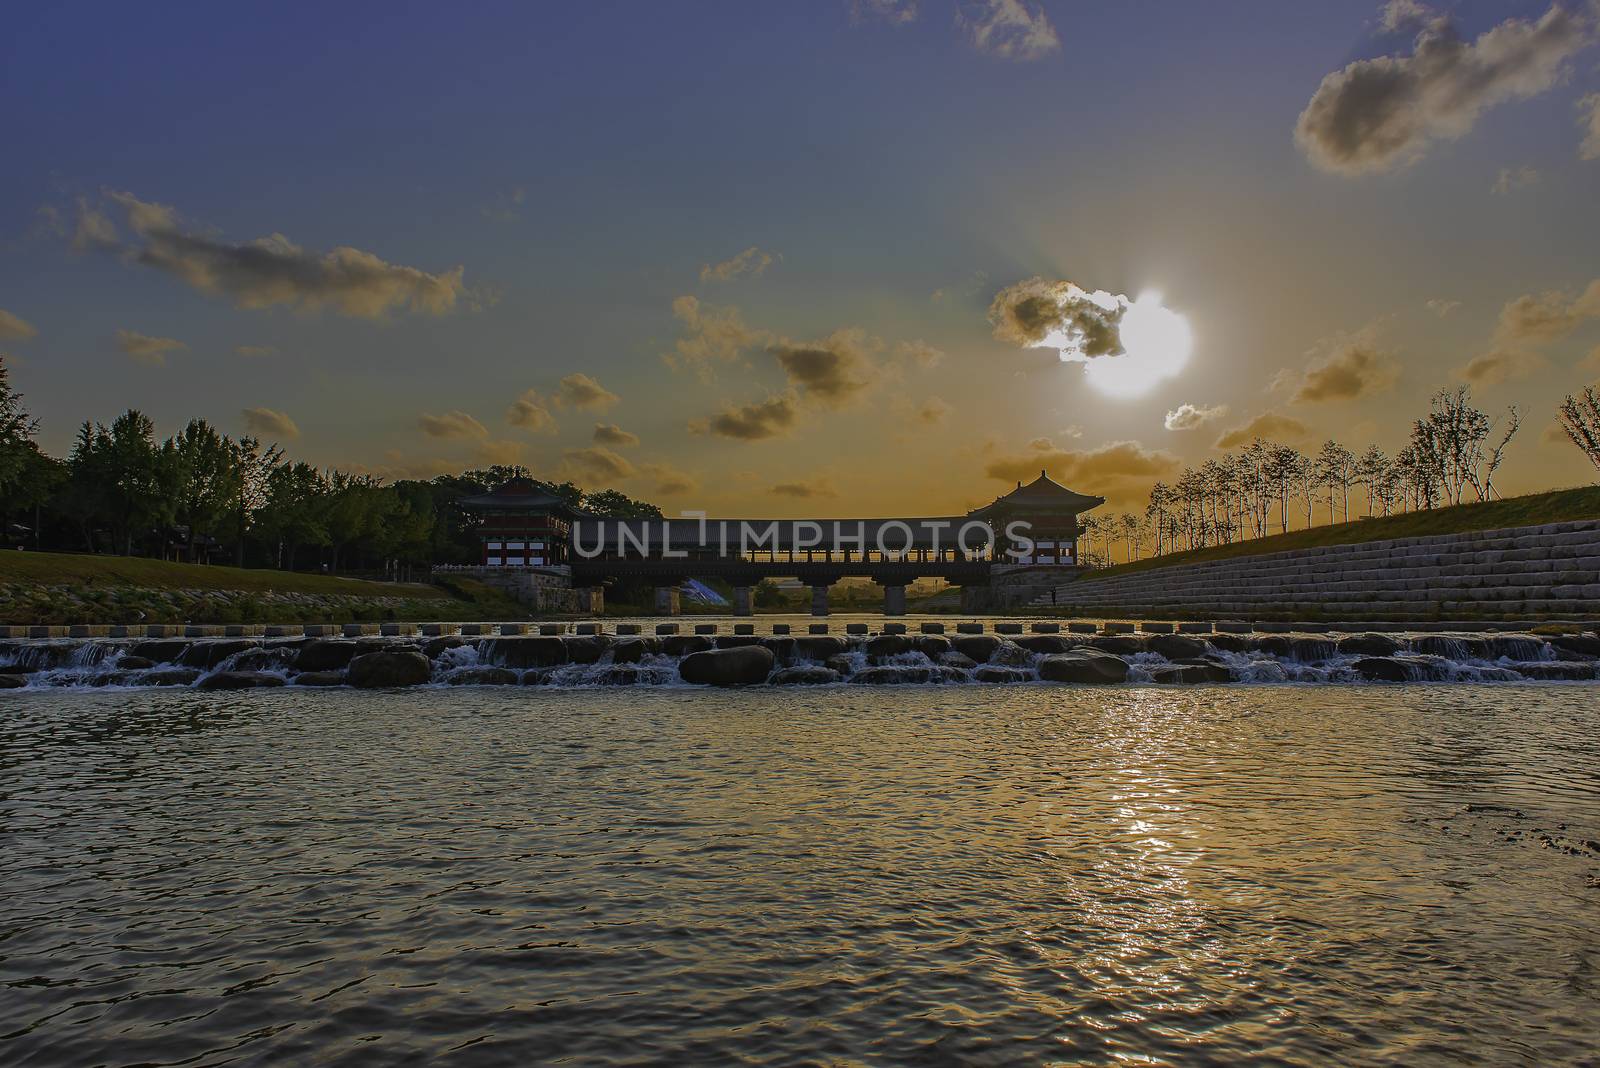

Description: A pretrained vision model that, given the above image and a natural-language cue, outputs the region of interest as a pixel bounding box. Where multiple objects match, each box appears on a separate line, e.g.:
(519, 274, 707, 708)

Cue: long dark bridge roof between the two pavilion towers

(573, 515, 990, 555)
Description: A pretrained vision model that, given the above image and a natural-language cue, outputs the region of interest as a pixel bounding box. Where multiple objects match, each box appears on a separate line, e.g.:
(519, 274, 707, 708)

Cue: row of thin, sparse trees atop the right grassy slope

(1082, 385, 1542, 566)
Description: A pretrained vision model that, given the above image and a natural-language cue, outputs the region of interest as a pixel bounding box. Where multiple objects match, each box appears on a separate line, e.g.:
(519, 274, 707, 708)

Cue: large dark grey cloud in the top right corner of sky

(1294, 5, 1594, 174)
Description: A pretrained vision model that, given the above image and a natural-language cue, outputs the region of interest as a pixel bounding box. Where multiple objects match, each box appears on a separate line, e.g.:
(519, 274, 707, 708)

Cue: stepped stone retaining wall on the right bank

(1034, 520, 1600, 620)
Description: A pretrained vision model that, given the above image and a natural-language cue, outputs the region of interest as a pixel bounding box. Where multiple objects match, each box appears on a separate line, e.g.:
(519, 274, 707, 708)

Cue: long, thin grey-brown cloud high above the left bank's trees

(74, 192, 466, 318)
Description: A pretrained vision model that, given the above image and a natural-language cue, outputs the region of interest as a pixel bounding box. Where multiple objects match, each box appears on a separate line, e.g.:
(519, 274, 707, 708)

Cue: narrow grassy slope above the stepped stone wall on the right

(1080, 486, 1600, 582)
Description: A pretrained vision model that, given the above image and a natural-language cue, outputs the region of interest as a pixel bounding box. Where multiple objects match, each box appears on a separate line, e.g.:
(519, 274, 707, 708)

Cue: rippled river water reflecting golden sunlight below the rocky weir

(0, 684, 1600, 1065)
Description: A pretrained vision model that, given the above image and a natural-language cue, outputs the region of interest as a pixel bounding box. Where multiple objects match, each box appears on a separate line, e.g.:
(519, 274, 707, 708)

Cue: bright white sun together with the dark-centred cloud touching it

(989, 278, 1194, 397)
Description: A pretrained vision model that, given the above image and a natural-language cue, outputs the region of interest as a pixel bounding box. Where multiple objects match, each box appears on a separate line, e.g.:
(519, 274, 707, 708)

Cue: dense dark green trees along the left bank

(0, 357, 661, 576)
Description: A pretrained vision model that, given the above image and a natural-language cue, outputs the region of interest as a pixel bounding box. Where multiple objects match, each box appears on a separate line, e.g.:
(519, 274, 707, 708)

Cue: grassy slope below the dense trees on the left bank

(0, 552, 450, 600)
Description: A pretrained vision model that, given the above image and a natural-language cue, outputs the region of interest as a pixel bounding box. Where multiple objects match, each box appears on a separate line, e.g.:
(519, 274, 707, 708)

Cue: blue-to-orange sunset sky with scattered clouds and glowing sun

(0, 0, 1600, 516)
